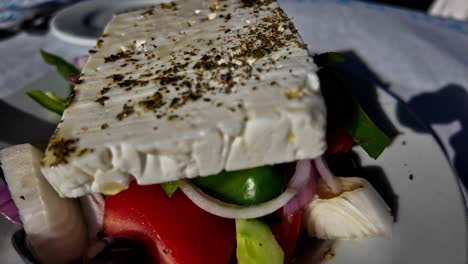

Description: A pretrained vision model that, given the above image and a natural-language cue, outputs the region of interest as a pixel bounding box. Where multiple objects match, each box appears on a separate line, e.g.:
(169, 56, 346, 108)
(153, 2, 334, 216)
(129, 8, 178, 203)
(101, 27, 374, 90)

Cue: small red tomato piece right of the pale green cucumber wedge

(270, 210, 302, 263)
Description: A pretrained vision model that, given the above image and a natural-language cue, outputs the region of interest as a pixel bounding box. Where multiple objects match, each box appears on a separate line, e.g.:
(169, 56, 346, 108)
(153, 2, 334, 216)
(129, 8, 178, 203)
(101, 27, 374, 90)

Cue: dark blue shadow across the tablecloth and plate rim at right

(330, 51, 468, 197)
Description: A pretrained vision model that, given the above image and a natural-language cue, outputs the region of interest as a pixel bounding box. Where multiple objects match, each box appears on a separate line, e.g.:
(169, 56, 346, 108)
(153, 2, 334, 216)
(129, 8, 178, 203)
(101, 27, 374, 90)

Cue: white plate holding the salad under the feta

(0, 69, 468, 264)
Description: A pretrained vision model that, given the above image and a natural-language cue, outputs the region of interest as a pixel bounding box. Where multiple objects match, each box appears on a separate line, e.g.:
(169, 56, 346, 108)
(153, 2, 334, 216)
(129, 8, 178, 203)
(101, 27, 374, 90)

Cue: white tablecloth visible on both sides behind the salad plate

(0, 0, 468, 190)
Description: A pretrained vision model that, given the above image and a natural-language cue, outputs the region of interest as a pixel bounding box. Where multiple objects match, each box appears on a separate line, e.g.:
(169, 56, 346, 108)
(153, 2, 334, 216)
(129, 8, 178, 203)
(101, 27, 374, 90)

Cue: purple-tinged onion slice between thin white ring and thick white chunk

(283, 160, 318, 216)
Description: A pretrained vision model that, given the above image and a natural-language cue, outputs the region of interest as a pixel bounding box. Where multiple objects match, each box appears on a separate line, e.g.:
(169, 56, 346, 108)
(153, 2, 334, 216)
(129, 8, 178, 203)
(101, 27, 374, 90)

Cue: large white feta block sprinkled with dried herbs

(42, 0, 326, 197)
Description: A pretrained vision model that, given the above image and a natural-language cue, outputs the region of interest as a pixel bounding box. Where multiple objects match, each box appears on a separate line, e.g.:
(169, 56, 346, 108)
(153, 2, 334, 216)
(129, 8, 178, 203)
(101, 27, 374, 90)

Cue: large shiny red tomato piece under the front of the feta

(104, 182, 235, 264)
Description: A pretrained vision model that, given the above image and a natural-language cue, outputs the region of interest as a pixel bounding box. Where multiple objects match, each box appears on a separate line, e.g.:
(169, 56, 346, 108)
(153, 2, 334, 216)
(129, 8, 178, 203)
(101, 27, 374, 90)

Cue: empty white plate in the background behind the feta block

(51, 0, 161, 47)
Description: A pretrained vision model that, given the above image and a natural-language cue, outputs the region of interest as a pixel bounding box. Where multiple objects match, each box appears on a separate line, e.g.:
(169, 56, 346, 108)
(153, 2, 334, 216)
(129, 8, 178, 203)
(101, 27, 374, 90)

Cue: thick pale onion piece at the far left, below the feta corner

(0, 144, 88, 264)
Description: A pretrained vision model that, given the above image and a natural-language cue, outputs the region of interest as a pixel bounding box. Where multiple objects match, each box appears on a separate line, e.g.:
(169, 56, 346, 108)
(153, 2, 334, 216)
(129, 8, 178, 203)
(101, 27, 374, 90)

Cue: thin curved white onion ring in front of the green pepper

(180, 181, 297, 219)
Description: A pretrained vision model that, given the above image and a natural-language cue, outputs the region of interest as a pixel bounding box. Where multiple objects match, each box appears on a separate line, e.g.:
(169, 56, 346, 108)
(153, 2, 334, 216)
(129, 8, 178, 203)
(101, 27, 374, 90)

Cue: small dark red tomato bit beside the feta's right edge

(325, 113, 354, 155)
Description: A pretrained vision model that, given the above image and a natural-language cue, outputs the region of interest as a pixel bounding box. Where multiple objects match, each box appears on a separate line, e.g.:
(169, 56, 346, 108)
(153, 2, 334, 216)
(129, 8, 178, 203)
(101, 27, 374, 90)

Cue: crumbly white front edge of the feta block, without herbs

(41, 77, 327, 197)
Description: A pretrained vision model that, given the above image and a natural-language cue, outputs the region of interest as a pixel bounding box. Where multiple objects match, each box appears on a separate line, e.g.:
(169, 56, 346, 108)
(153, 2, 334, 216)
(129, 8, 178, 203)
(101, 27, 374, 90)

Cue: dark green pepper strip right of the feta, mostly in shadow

(314, 52, 391, 159)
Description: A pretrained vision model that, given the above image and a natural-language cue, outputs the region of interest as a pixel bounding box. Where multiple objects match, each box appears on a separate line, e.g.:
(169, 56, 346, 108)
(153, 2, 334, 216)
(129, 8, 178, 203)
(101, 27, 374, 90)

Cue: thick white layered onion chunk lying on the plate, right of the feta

(302, 177, 393, 240)
